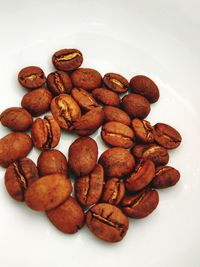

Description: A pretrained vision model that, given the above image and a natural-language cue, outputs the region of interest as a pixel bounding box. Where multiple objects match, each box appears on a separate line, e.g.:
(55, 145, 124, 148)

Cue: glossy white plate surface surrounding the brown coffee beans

(0, 0, 200, 267)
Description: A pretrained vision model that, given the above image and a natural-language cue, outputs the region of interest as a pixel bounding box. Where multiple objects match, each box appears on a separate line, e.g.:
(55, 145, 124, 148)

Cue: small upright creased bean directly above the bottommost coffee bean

(101, 178, 125, 206)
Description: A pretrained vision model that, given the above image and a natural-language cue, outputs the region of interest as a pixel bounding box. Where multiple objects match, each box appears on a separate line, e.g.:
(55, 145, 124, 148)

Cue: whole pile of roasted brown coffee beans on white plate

(0, 49, 181, 242)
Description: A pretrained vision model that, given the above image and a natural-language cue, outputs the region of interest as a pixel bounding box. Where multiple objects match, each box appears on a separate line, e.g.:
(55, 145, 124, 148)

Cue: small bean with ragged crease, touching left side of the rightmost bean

(132, 118, 154, 143)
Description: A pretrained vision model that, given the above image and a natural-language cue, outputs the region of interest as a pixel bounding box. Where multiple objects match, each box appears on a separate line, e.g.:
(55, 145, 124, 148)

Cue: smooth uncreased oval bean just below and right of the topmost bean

(71, 68, 102, 91)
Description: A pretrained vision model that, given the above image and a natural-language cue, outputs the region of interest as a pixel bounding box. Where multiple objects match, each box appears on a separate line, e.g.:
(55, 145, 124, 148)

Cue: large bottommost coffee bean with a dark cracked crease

(86, 203, 129, 242)
